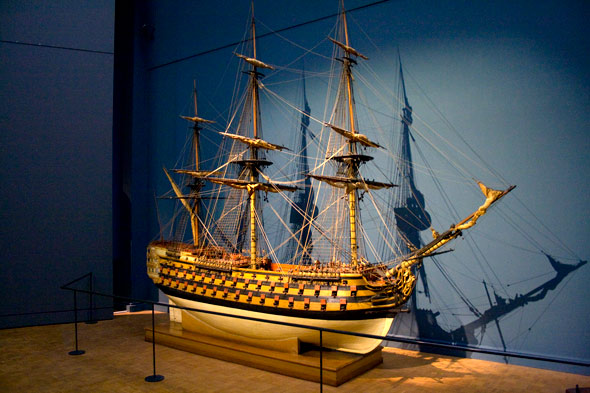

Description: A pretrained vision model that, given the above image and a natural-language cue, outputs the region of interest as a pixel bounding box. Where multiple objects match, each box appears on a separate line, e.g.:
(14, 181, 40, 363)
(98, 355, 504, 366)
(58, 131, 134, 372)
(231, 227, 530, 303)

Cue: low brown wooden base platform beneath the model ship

(145, 322, 383, 386)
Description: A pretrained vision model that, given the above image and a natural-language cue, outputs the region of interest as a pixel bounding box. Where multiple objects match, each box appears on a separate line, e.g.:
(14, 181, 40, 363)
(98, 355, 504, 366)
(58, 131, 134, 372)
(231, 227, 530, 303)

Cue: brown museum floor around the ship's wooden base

(0, 314, 590, 393)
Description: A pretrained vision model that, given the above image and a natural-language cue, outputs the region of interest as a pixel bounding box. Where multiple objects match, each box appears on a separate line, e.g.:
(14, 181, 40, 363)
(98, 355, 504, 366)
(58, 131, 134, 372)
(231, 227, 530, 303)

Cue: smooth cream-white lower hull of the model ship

(168, 296, 393, 353)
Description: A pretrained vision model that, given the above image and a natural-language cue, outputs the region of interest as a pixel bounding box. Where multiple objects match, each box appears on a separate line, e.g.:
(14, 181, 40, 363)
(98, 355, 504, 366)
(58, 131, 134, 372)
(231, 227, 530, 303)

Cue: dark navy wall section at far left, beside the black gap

(0, 0, 114, 327)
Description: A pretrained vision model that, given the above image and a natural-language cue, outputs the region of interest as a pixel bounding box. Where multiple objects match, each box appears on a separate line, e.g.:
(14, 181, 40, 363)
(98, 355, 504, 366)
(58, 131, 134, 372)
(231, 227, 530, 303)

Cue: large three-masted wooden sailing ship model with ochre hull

(147, 4, 513, 353)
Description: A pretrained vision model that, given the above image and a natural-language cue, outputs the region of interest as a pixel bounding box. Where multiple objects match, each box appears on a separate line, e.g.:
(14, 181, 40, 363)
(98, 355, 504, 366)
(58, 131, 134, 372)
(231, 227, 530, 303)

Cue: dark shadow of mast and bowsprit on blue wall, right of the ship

(390, 57, 586, 357)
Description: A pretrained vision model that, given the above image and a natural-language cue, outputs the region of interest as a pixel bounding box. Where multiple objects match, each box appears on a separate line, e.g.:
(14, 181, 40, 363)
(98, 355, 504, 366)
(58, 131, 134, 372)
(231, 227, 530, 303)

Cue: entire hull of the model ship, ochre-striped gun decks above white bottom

(147, 242, 405, 353)
